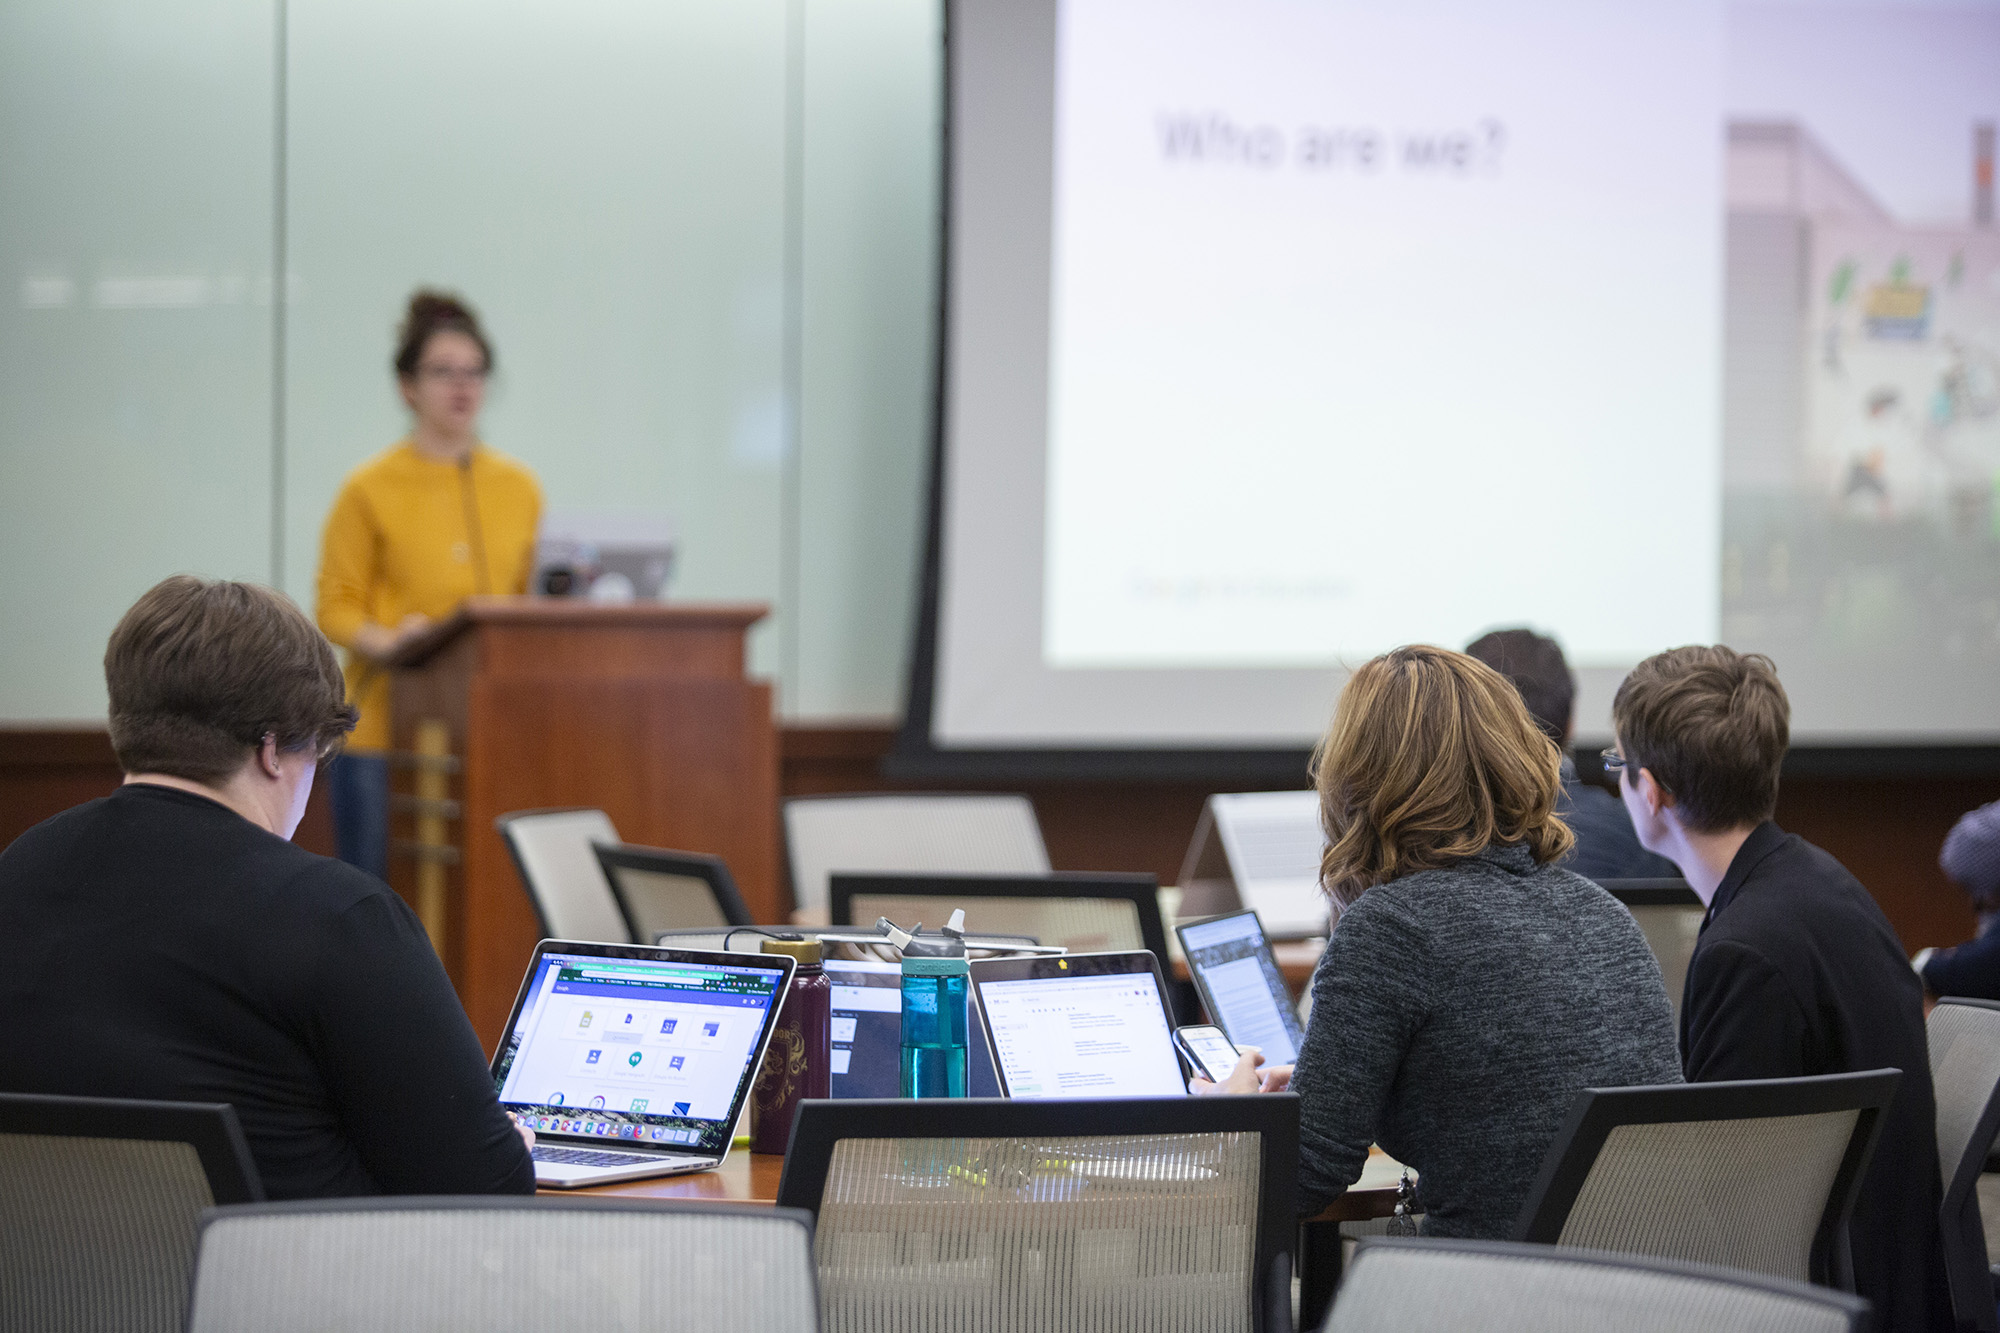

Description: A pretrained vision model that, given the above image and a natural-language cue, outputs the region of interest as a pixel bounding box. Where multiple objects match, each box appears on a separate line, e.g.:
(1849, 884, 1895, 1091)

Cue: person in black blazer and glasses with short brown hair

(1604, 646, 1952, 1333)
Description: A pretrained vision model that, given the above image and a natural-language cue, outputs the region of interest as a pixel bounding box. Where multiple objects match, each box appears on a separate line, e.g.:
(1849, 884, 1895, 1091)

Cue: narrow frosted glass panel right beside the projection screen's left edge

(794, 0, 944, 717)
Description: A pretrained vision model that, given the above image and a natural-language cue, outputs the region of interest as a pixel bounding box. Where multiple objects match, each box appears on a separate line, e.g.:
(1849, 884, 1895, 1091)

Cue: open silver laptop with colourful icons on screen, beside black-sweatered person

(494, 939, 794, 1189)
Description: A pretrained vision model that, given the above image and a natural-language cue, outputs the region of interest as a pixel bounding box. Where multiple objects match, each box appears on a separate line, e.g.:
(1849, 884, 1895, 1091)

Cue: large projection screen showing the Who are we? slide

(918, 0, 2000, 751)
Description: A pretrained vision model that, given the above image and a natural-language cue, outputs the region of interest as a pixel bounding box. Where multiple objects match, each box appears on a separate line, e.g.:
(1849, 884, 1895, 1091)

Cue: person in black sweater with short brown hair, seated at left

(0, 576, 534, 1199)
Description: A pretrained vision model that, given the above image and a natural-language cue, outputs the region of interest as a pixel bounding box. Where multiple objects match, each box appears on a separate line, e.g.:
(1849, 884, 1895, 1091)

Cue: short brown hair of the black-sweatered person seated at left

(104, 574, 358, 783)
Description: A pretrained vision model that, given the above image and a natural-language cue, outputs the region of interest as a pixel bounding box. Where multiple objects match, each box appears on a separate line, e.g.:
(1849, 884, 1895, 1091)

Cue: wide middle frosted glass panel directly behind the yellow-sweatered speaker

(284, 0, 786, 673)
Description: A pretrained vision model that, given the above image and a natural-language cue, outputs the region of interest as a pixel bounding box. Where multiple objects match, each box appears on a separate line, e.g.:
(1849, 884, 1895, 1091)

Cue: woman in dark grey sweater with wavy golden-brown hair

(1198, 646, 1680, 1239)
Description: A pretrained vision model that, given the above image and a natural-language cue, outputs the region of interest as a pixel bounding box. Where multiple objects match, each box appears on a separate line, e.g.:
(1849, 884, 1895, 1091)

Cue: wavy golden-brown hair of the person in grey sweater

(1312, 646, 1576, 907)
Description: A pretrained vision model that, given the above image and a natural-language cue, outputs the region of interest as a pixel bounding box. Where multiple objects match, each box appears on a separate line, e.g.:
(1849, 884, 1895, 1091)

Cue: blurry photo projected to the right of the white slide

(1722, 4, 2000, 737)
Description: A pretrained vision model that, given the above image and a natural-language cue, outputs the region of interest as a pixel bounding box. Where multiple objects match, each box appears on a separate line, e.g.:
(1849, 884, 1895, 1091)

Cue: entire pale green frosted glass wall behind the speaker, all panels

(0, 0, 942, 725)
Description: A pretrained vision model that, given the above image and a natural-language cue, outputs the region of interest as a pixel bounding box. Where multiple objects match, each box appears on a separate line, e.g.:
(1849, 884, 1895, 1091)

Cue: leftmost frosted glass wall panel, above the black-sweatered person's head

(0, 0, 274, 721)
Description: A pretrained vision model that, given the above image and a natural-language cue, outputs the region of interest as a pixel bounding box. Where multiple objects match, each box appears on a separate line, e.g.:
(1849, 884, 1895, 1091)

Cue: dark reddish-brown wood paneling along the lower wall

(0, 727, 2000, 951)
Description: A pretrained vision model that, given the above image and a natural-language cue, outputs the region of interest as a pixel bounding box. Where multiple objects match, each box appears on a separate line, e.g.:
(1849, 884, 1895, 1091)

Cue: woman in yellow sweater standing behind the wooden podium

(318, 290, 542, 877)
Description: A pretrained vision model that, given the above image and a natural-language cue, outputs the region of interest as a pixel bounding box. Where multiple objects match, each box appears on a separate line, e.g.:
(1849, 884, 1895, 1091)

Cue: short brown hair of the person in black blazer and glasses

(1612, 644, 1792, 833)
